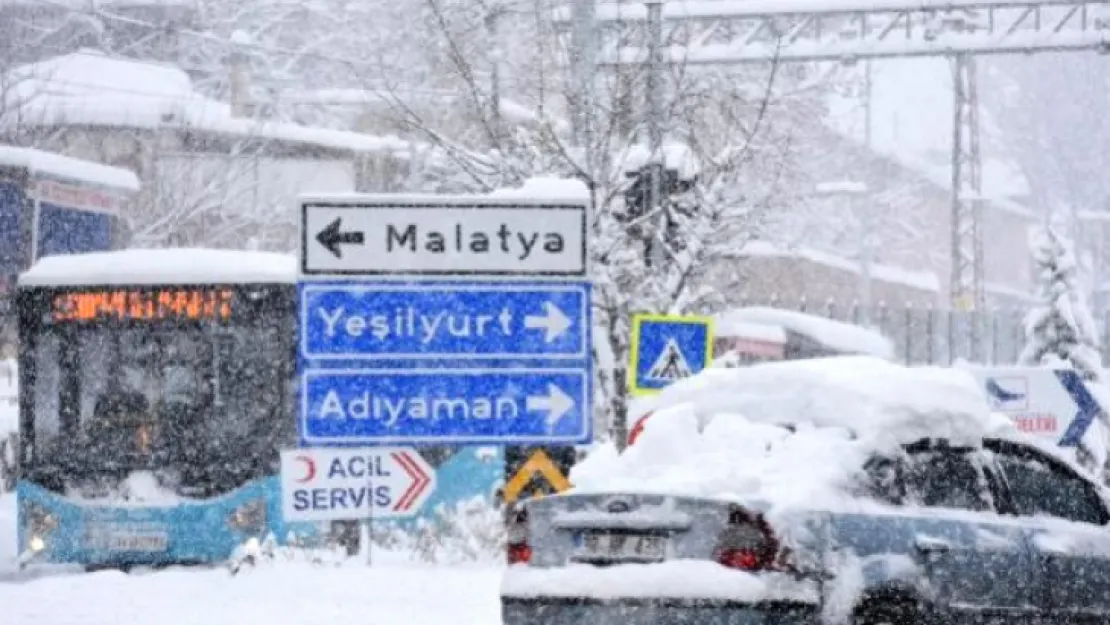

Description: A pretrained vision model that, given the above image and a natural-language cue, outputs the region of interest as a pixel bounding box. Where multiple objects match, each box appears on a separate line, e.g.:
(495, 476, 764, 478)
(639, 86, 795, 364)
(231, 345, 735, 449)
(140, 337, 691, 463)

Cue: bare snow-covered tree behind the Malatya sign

(370, 0, 824, 444)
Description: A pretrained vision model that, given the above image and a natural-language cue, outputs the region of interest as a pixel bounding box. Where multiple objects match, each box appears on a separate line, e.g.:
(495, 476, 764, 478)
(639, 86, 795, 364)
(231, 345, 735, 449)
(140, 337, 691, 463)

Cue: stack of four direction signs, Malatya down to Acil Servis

(283, 194, 593, 532)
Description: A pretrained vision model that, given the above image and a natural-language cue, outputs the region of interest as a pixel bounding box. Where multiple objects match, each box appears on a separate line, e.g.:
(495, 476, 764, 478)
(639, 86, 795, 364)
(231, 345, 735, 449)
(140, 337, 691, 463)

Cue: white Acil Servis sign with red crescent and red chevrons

(281, 447, 435, 522)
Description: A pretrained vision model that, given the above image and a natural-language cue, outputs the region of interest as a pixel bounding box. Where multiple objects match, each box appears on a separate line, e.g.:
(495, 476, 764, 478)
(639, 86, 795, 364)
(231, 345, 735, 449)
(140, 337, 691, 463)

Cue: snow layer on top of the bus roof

(19, 248, 296, 286)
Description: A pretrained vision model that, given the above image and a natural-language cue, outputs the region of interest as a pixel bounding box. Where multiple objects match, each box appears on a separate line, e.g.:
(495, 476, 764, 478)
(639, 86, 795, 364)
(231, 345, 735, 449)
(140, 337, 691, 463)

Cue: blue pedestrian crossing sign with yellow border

(628, 314, 713, 395)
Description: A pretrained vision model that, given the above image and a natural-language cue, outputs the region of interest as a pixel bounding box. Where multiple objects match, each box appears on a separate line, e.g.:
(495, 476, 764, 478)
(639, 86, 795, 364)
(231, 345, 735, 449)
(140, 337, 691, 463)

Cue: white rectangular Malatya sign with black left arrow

(301, 196, 586, 276)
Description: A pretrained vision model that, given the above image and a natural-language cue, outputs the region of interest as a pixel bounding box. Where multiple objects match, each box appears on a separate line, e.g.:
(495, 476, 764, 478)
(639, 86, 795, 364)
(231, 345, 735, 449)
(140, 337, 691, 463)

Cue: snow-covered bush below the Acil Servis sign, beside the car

(372, 496, 505, 564)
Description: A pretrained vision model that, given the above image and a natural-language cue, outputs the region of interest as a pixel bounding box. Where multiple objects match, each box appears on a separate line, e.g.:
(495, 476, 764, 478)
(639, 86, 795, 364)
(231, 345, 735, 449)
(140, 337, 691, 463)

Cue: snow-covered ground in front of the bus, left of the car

(0, 562, 501, 625)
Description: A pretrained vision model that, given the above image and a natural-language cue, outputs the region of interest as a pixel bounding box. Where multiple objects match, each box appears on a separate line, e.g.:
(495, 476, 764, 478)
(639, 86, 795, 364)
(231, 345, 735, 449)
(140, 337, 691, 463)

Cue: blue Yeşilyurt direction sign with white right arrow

(301, 283, 589, 361)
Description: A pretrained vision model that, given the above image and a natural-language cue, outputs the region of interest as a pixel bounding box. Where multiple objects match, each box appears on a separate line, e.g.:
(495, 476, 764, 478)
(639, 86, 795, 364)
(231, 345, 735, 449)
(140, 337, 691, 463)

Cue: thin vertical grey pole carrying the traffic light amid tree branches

(646, 0, 667, 273)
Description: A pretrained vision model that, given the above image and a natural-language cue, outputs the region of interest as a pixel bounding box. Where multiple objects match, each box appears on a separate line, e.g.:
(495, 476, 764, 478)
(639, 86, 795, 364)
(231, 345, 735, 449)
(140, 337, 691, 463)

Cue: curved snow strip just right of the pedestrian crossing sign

(714, 306, 895, 360)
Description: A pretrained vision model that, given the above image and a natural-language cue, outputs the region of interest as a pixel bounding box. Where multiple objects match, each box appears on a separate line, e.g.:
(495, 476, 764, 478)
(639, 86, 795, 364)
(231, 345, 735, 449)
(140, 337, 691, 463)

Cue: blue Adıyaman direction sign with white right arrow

(300, 367, 592, 446)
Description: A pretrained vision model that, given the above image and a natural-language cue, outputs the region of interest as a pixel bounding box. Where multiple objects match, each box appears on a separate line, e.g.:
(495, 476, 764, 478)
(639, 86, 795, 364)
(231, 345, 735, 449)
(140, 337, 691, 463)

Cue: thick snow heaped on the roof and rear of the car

(571, 356, 1012, 510)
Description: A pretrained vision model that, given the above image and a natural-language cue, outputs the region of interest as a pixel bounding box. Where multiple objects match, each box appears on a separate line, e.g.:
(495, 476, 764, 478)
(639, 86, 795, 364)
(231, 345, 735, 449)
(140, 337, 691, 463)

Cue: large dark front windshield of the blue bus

(21, 286, 295, 497)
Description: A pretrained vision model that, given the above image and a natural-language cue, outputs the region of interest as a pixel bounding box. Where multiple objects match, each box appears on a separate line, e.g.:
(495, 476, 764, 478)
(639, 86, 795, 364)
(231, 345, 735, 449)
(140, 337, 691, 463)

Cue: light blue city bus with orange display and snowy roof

(16, 250, 319, 567)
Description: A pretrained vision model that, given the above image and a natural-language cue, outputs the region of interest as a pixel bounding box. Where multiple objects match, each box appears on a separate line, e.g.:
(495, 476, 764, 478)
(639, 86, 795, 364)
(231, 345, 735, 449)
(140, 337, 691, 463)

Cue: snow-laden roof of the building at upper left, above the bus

(3, 50, 411, 152)
